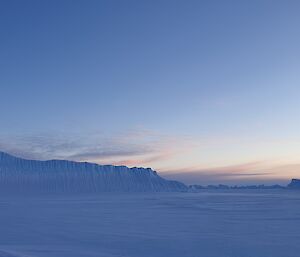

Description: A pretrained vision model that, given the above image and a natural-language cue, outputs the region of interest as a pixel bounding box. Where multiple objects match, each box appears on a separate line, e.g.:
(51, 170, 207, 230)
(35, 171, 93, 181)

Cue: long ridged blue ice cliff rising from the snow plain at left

(0, 152, 187, 192)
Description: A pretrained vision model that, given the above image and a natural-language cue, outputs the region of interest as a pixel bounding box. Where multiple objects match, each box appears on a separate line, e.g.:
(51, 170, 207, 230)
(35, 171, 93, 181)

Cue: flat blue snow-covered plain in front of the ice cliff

(0, 190, 300, 257)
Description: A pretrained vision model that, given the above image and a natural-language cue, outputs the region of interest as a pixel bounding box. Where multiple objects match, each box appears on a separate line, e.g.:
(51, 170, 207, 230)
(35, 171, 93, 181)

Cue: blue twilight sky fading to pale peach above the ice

(0, 0, 300, 184)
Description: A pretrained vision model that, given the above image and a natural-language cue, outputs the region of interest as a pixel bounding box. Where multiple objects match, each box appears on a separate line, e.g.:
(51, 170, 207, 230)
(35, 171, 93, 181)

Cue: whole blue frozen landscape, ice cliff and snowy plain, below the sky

(0, 153, 300, 257)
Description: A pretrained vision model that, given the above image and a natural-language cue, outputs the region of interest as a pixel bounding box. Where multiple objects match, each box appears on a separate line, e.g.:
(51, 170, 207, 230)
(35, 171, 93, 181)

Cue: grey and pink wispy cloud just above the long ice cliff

(0, 129, 196, 166)
